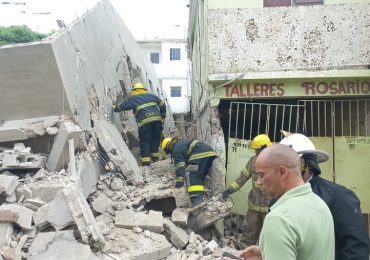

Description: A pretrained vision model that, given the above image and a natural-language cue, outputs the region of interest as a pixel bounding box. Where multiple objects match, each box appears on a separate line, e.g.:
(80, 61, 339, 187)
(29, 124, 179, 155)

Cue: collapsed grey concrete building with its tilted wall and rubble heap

(0, 1, 231, 260)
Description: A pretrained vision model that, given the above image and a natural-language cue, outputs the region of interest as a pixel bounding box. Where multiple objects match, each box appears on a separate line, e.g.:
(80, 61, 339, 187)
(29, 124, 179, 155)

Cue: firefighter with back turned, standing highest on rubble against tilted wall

(113, 83, 166, 166)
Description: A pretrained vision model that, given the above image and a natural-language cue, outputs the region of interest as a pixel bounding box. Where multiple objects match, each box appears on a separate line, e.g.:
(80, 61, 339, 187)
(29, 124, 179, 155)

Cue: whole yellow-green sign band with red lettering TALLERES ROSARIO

(216, 78, 370, 98)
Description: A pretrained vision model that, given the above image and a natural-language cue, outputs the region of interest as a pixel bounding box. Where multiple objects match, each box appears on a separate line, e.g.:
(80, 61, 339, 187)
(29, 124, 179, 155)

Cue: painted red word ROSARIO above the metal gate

(301, 80, 370, 96)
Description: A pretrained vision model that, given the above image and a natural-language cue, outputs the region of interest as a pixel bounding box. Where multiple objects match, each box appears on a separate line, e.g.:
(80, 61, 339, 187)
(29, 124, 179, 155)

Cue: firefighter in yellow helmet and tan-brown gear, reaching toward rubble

(222, 134, 272, 246)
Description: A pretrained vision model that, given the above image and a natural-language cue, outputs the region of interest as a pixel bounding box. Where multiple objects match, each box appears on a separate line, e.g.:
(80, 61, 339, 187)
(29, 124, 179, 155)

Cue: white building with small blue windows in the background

(138, 28, 191, 114)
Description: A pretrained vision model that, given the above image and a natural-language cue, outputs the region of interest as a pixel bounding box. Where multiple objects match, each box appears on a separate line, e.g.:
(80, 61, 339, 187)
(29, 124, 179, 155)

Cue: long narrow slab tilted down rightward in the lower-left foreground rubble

(63, 183, 105, 248)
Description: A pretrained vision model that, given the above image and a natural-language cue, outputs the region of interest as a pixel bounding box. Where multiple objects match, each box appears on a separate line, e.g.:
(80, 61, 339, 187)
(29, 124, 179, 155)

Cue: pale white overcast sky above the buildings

(0, 0, 189, 39)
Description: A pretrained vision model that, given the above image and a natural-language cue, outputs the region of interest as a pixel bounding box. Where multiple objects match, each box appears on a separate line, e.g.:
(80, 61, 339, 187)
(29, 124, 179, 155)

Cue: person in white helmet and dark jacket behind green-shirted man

(280, 134, 369, 260)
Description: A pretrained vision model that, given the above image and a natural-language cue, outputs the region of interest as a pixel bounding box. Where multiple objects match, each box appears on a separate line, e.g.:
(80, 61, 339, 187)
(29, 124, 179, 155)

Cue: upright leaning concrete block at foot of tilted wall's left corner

(46, 121, 82, 171)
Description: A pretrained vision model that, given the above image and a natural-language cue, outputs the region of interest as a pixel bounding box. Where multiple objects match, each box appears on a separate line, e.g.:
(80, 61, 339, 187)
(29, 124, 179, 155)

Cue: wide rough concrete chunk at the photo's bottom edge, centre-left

(103, 228, 171, 260)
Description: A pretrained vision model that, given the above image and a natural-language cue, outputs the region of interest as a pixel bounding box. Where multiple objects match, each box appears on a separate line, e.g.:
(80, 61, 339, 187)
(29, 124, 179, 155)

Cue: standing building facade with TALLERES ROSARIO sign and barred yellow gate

(188, 0, 370, 228)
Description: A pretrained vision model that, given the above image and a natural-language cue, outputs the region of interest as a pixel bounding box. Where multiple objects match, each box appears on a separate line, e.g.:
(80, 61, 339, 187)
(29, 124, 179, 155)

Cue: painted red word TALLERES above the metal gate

(225, 82, 285, 98)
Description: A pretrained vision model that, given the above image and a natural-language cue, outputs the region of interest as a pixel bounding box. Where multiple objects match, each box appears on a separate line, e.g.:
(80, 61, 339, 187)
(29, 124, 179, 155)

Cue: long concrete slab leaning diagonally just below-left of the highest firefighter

(92, 115, 143, 185)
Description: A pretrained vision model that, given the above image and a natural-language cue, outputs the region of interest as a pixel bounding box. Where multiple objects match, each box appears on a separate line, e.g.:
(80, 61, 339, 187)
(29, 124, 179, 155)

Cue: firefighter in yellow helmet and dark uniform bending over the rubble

(162, 138, 217, 207)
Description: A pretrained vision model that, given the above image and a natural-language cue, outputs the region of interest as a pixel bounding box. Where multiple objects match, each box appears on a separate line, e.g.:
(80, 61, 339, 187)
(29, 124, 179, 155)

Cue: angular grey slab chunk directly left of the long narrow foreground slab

(33, 191, 74, 230)
